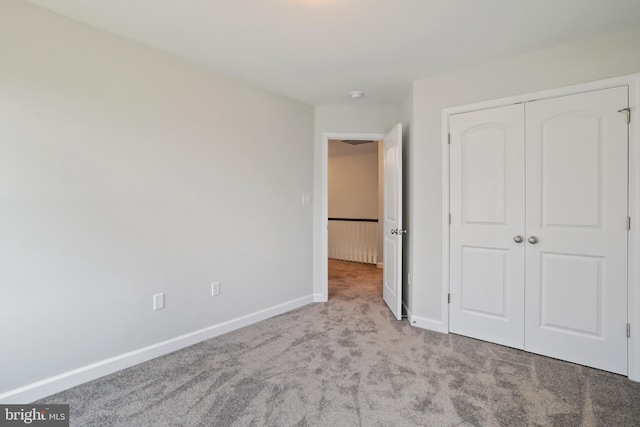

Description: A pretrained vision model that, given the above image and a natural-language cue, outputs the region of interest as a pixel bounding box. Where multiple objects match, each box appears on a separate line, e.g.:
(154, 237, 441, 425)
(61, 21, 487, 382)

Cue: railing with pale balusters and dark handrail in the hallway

(329, 218, 378, 264)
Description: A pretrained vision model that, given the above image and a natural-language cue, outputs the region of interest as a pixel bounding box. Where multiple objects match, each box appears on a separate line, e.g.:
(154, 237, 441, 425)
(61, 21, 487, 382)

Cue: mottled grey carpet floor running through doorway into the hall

(36, 260, 640, 427)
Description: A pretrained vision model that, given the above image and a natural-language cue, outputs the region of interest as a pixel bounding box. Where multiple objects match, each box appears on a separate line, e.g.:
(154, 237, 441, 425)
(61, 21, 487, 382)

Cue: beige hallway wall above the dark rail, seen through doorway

(328, 150, 378, 219)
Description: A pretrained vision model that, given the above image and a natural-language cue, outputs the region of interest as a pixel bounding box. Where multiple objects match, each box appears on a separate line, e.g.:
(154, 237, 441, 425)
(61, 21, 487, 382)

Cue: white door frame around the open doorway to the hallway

(313, 132, 386, 302)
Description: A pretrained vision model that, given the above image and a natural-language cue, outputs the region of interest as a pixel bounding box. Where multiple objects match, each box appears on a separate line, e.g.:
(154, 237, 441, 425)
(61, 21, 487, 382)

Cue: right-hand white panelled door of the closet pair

(525, 86, 628, 374)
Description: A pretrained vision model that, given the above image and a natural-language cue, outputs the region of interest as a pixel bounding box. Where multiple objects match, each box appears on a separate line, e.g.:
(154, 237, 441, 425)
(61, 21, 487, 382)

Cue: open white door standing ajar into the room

(382, 123, 404, 320)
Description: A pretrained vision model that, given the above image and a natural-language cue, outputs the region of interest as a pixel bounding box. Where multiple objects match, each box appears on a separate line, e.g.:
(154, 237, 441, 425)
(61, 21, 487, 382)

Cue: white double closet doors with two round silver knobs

(449, 86, 628, 374)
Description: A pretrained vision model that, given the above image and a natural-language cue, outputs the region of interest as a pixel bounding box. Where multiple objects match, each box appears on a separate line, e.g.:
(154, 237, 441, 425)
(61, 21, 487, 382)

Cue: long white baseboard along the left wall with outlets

(0, 295, 315, 404)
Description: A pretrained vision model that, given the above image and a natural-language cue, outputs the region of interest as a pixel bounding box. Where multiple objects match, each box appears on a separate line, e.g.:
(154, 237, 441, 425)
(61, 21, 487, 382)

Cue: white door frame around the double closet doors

(441, 74, 640, 381)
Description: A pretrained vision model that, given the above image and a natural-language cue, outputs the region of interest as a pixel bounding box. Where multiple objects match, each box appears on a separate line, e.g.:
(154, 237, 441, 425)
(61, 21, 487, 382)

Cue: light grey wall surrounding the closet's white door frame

(409, 26, 640, 330)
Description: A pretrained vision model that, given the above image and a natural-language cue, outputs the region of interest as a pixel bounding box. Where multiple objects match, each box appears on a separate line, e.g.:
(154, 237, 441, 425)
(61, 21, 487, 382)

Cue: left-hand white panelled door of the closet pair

(449, 104, 525, 349)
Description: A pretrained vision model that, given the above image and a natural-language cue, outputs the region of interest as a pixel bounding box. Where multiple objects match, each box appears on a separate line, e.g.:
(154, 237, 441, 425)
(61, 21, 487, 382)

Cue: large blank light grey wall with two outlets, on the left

(0, 0, 314, 401)
